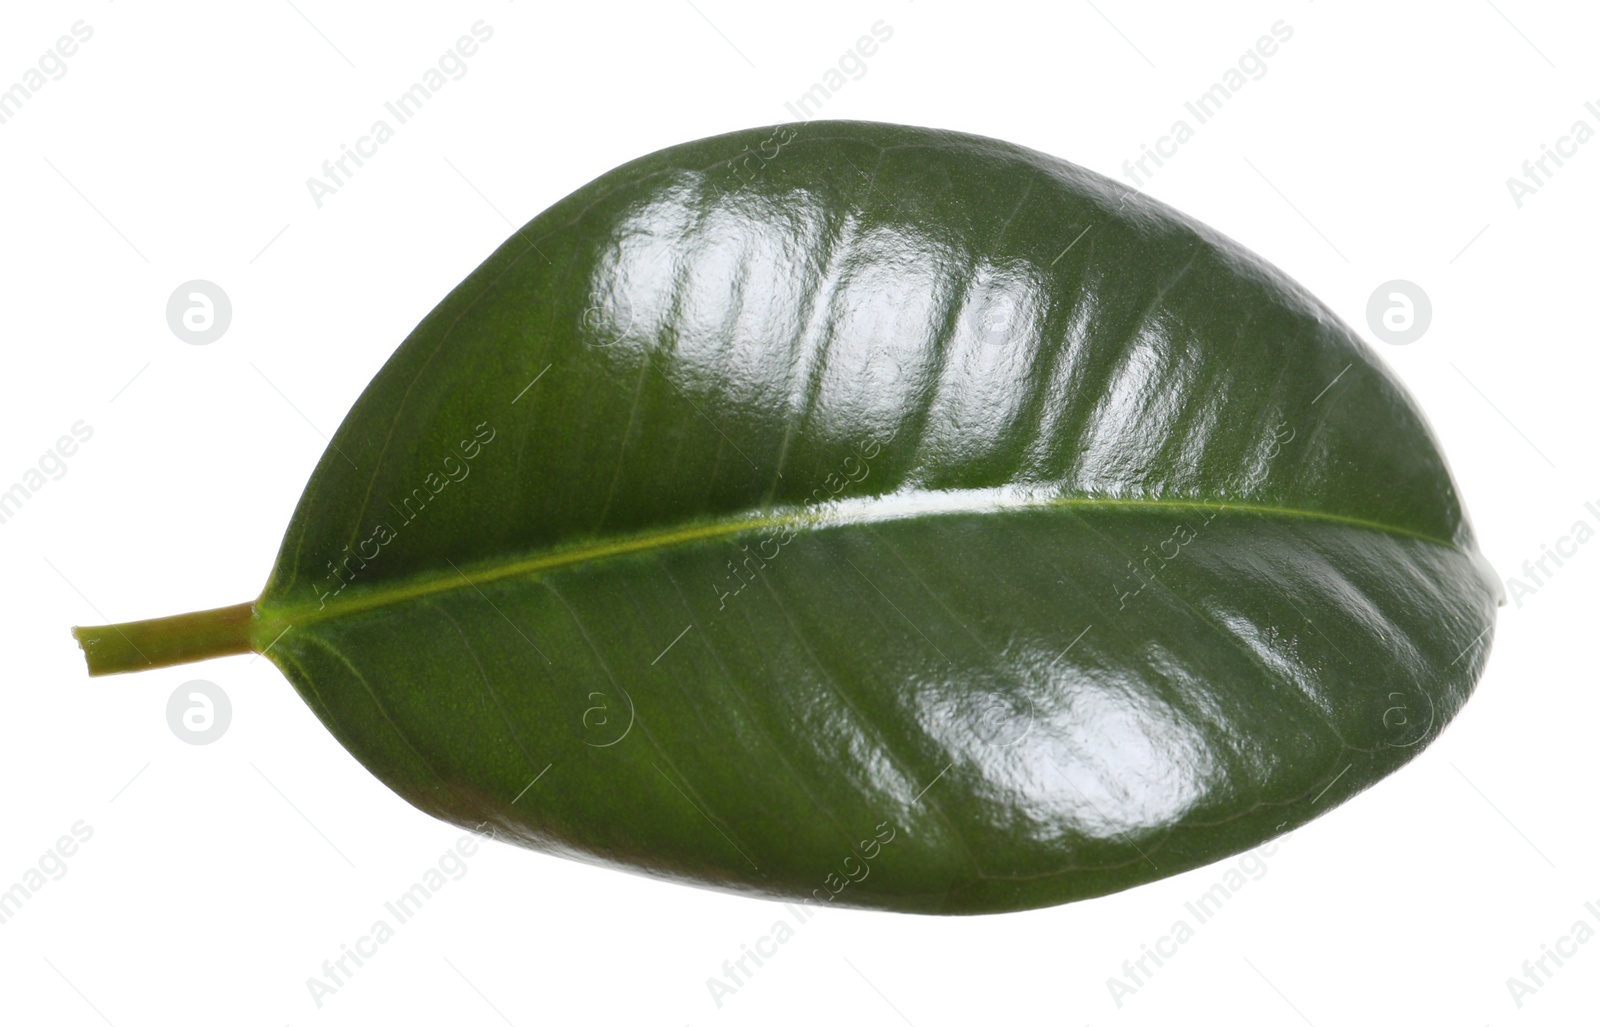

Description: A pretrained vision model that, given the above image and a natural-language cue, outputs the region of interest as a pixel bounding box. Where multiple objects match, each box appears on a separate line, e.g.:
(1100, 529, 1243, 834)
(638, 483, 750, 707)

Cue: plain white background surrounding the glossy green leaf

(0, 0, 1600, 1027)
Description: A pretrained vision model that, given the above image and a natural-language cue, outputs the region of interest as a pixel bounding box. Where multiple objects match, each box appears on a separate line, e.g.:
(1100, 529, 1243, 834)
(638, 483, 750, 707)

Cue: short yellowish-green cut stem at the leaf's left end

(72, 601, 256, 677)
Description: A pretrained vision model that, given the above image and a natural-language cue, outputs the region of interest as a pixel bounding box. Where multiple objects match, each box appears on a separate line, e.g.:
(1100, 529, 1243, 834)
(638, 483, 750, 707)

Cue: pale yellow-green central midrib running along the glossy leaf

(256, 490, 1459, 630)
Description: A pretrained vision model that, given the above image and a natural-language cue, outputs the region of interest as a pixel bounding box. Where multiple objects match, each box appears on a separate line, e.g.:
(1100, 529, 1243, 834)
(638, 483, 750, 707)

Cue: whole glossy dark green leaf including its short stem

(78, 122, 1501, 913)
